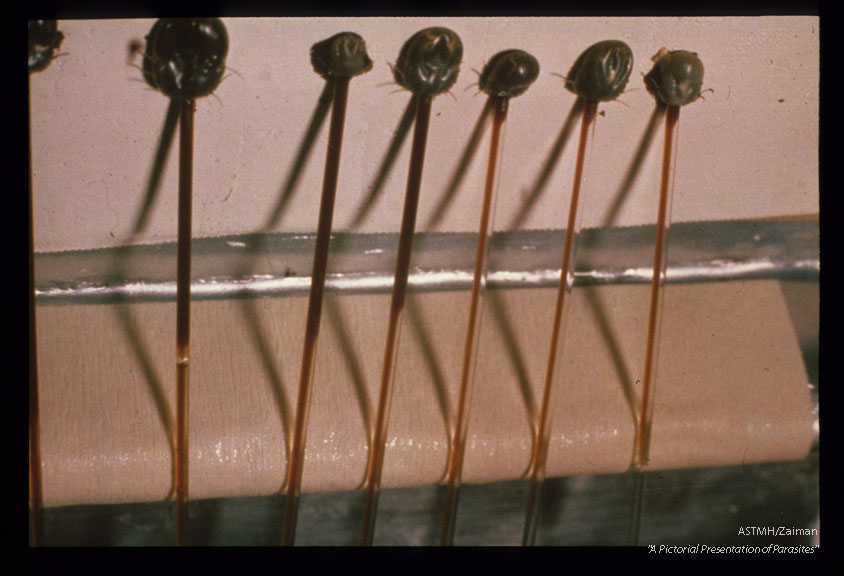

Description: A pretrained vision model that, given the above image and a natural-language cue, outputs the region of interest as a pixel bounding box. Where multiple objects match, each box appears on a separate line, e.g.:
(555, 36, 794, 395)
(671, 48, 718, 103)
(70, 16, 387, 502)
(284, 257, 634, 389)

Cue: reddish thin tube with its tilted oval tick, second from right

(522, 40, 633, 546)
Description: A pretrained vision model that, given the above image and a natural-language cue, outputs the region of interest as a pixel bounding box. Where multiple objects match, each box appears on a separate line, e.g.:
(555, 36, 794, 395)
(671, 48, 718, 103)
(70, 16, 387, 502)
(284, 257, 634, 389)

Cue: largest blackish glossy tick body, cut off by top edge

(143, 18, 229, 99)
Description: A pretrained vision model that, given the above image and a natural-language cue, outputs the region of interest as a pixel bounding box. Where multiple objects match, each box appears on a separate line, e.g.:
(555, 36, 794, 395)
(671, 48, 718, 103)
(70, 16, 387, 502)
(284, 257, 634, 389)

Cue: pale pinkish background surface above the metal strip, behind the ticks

(31, 17, 820, 251)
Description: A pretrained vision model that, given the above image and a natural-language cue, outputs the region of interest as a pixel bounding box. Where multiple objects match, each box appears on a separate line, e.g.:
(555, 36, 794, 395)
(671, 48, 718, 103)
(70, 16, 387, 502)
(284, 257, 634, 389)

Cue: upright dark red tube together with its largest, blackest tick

(143, 18, 229, 546)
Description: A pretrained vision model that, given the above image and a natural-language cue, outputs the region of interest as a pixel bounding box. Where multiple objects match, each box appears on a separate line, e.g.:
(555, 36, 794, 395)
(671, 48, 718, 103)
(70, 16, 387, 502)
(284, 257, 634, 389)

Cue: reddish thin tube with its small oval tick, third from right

(440, 50, 539, 546)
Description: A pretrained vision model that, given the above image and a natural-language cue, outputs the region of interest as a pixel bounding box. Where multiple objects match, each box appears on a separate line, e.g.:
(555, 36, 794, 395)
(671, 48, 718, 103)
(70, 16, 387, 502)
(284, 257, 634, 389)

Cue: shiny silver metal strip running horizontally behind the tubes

(35, 220, 820, 304)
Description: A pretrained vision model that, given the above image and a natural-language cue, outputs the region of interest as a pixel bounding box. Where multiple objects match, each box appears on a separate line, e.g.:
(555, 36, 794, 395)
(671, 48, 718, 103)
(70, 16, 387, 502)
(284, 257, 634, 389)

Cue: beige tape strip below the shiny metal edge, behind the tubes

(38, 281, 812, 506)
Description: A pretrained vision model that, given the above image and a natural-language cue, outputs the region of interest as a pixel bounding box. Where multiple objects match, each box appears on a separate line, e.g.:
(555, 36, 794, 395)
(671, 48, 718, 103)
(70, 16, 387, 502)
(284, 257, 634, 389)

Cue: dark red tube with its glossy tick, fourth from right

(361, 28, 463, 546)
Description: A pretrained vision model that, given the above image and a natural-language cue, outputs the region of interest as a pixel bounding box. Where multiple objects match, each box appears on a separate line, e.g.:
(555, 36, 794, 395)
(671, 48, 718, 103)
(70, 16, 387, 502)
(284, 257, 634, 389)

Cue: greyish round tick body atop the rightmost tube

(645, 48, 703, 106)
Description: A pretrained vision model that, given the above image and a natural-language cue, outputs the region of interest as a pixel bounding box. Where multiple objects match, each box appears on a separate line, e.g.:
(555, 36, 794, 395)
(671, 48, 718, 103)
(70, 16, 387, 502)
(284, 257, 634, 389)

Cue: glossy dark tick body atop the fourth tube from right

(393, 28, 463, 96)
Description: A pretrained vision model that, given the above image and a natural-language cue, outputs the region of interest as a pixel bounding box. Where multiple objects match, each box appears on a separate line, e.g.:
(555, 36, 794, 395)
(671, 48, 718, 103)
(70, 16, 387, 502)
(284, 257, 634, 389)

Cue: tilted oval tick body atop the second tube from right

(566, 40, 633, 102)
